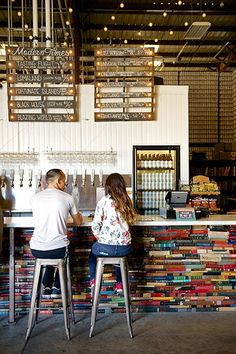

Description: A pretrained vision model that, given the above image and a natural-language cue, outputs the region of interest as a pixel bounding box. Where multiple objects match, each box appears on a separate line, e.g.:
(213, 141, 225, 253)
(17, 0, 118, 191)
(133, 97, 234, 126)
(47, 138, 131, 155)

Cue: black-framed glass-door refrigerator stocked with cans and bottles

(133, 145, 180, 215)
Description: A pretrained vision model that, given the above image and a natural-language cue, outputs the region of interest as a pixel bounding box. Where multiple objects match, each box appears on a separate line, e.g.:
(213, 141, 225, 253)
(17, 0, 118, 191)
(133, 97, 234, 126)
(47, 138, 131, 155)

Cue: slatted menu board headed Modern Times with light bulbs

(6, 46, 77, 122)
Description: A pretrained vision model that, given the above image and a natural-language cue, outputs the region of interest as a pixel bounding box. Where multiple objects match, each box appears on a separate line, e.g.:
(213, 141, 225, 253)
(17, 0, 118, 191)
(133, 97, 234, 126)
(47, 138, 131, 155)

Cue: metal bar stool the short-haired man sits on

(25, 257, 75, 341)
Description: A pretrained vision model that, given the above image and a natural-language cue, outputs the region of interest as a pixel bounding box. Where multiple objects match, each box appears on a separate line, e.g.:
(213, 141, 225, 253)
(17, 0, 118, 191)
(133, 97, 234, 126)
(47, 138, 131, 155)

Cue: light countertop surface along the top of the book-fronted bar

(4, 214, 236, 228)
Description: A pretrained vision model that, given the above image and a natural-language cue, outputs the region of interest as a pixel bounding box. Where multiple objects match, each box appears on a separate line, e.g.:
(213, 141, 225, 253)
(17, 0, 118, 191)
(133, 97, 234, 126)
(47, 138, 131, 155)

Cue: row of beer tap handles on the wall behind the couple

(0, 169, 103, 188)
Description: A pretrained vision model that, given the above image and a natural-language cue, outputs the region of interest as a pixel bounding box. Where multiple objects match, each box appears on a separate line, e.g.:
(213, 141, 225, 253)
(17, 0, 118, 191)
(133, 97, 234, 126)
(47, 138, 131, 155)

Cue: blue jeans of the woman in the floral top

(89, 242, 132, 283)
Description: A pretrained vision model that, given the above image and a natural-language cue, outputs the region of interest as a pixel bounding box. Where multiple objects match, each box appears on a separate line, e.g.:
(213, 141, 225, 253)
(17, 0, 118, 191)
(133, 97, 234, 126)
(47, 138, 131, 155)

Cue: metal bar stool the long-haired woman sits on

(89, 256, 133, 338)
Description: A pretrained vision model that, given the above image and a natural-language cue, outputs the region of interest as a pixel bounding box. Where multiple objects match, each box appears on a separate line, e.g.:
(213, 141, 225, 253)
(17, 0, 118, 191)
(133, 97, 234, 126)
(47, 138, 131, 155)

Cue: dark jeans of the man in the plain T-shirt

(31, 247, 68, 289)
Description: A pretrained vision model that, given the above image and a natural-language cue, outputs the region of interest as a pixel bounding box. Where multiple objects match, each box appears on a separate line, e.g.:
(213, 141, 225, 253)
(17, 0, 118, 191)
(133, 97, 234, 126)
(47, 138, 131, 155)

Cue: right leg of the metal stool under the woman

(120, 259, 133, 338)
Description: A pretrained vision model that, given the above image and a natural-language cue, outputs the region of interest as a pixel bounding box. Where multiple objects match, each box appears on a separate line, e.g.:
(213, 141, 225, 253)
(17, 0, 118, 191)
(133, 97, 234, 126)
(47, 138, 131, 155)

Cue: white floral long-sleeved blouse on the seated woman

(92, 195, 131, 246)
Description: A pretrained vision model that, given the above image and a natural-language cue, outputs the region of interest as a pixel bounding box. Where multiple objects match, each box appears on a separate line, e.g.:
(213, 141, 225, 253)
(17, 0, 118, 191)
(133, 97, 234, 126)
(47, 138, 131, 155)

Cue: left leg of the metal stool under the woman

(89, 259, 103, 338)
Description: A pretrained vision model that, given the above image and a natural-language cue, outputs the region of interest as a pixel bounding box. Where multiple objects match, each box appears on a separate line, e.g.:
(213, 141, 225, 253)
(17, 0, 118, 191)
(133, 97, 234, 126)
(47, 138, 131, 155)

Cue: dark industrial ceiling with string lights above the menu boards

(0, 0, 236, 78)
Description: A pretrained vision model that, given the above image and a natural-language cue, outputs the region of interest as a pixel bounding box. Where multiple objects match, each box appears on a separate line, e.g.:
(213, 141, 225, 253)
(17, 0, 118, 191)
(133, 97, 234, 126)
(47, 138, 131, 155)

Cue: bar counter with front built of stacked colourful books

(0, 215, 236, 322)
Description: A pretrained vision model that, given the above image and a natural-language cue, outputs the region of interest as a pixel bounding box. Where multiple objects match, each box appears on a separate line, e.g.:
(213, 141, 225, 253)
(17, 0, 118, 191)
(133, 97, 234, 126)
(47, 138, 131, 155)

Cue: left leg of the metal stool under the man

(25, 260, 41, 341)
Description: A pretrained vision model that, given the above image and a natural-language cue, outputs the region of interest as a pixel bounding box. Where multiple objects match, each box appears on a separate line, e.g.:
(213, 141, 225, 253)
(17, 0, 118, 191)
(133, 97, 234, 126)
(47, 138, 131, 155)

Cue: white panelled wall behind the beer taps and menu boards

(0, 85, 189, 181)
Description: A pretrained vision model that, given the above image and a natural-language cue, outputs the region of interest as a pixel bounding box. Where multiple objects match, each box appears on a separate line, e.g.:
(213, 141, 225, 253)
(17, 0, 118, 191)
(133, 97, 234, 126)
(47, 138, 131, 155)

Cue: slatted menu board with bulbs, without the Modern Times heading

(95, 47, 154, 122)
